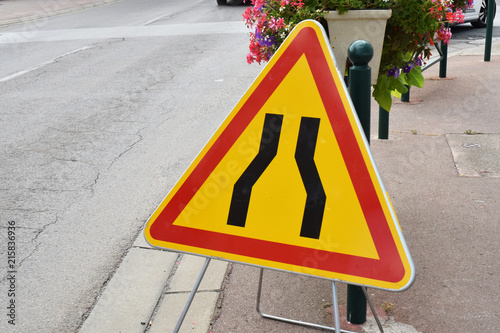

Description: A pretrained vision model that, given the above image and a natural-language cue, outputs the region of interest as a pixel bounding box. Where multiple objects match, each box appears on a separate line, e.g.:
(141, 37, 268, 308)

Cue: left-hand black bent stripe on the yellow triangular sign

(227, 113, 283, 227)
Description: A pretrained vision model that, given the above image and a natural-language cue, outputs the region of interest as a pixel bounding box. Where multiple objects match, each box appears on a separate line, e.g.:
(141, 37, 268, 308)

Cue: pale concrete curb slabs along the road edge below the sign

(79, 233, 228, 333)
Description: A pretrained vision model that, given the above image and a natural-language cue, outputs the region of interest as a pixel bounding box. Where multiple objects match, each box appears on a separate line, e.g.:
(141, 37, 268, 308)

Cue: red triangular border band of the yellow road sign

(150, 27, 405, 283)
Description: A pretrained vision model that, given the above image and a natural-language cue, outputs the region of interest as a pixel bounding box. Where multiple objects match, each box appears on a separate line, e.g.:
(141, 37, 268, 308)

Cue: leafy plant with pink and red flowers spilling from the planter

(243, 0, 472, 111)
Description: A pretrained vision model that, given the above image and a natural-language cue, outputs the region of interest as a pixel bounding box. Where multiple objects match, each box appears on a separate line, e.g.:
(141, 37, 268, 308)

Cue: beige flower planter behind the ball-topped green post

(325, 9, 392, 84)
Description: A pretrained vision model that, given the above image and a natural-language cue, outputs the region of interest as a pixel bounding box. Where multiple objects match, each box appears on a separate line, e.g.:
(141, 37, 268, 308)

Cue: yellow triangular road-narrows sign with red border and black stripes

(145, 21, 414, 290)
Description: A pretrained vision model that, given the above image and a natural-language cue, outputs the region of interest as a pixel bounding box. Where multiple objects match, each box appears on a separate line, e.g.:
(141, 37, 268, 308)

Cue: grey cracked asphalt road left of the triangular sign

(0, 0, 260, 333)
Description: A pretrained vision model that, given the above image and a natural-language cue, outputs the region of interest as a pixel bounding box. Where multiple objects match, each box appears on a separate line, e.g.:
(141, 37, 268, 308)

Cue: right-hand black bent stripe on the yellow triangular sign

(295, 117, 326, 239)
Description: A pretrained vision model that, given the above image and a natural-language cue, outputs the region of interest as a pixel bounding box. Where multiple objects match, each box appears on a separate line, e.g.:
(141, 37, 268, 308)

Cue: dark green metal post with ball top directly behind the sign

(347, 40, 373, 325)
